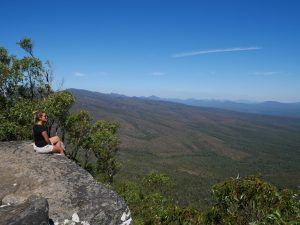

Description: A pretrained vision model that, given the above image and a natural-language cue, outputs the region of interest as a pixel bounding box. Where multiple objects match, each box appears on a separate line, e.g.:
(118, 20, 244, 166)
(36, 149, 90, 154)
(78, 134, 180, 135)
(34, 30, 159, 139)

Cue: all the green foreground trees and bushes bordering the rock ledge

(0, 38, 300, 225)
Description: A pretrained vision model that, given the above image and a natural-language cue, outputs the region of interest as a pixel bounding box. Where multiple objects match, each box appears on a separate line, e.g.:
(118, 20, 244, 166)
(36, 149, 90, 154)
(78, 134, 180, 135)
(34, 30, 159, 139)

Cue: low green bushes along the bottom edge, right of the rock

(114, 172, 300, 225)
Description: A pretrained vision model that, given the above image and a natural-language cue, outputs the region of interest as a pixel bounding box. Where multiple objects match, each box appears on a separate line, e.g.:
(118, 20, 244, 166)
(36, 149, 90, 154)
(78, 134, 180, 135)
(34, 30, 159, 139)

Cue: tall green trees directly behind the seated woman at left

(0, 38, 74, 141)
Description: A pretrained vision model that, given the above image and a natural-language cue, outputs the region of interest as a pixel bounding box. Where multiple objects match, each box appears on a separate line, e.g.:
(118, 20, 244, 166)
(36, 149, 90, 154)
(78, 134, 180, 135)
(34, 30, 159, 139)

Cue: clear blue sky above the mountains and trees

(0, 0, 300, 102)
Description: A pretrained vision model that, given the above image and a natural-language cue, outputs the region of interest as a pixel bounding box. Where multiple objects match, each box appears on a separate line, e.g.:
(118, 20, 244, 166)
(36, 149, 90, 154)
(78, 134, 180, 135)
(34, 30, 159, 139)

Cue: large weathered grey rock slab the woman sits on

(0, 141, 131, 225)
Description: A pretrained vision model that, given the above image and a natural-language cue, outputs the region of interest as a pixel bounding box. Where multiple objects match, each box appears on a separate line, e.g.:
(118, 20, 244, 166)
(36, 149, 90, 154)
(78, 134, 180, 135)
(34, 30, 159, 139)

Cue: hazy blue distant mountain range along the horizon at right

(141, 96, 300, 118)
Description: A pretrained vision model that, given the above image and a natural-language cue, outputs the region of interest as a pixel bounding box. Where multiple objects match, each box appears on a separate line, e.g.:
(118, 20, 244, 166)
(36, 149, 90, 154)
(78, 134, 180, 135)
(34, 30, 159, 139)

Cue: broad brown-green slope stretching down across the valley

(70, 89, 300, 207)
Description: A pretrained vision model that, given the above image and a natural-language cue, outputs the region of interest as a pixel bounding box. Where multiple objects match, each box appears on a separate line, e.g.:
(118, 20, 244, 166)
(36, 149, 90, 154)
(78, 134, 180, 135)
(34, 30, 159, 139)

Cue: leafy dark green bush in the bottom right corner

(206, 176, 300, 225)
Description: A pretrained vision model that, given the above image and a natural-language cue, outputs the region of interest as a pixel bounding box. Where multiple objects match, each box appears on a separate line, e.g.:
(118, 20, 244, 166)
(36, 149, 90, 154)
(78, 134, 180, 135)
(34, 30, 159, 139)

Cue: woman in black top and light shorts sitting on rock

(33, 112, 64, 155)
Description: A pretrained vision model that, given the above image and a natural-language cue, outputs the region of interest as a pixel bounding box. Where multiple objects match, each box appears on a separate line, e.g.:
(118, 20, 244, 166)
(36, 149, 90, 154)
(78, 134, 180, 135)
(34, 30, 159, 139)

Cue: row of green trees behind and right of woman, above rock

(0, 37, 120, 189)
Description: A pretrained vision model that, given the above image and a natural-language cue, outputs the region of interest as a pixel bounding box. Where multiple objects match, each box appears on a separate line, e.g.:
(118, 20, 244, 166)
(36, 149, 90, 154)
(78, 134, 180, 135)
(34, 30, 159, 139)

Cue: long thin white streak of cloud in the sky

(172, 47, 261, 58)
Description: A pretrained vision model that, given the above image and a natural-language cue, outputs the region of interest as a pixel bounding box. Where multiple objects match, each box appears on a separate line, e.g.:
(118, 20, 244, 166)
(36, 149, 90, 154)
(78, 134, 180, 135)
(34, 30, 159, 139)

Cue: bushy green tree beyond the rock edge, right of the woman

(66, 111, 121, 183)
